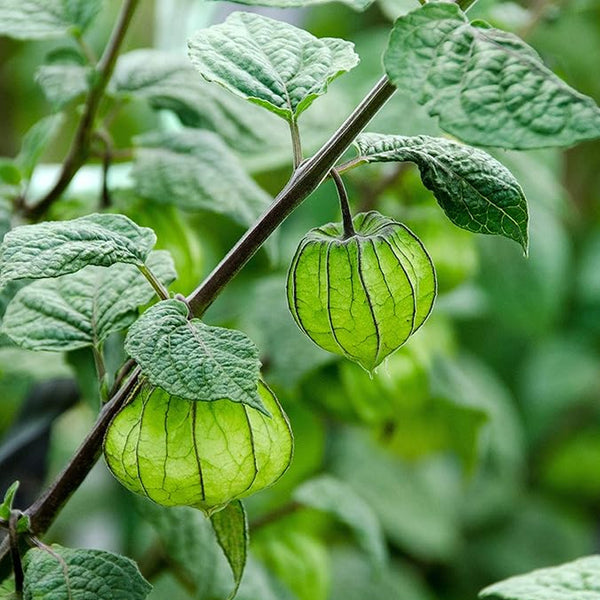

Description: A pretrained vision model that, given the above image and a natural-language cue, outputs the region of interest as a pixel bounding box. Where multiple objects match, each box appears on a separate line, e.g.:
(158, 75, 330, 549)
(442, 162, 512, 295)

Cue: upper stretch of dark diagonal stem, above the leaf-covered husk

(187, 77, 396, 317)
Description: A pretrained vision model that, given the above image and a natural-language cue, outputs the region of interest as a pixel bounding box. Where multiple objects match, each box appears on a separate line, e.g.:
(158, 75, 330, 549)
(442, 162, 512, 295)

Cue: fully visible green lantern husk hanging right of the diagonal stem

(287, 211, 436, 371)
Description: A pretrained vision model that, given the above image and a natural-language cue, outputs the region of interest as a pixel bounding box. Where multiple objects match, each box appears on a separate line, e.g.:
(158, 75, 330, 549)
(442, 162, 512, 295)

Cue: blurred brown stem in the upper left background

(23, 0, 139, 221)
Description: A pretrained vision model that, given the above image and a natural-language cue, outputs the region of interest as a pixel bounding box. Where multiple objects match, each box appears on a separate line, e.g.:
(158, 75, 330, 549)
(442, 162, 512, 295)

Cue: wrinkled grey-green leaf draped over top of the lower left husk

(125, 300, 265, 411)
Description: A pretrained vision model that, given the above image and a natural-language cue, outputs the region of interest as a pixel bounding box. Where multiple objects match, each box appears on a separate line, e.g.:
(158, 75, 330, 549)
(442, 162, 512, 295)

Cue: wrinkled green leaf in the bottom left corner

(23, 544, 152, 600)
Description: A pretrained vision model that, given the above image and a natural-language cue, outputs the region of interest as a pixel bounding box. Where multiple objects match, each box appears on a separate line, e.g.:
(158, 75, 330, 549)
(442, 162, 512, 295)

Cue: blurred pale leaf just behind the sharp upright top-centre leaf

(114, 49, 282, 152)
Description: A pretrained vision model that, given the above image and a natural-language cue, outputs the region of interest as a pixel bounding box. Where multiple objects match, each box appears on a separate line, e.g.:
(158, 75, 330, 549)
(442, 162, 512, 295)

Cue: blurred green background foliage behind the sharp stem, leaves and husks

(0, 0, 600, 600)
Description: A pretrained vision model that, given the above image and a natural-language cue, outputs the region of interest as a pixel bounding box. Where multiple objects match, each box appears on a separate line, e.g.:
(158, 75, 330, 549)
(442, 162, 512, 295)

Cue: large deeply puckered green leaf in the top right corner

(384, 2, 600, 149)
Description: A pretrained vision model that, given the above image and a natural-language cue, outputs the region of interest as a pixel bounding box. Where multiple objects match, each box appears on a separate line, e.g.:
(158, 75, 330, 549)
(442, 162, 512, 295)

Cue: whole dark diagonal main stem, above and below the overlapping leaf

(0, 77, 396, 561)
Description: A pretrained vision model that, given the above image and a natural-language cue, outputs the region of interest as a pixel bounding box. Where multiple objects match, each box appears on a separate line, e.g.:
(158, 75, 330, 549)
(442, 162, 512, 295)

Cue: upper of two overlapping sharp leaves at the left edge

(0, 214, 156, 287)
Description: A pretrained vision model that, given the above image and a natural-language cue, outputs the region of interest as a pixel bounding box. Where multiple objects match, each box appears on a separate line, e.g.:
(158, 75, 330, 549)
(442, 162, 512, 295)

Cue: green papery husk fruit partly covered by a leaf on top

(104, 381, 293, 514)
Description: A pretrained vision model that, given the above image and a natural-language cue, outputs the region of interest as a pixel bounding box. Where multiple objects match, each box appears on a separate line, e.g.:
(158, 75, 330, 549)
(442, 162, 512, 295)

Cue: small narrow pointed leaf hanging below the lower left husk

(210, 500, 248, 599)
